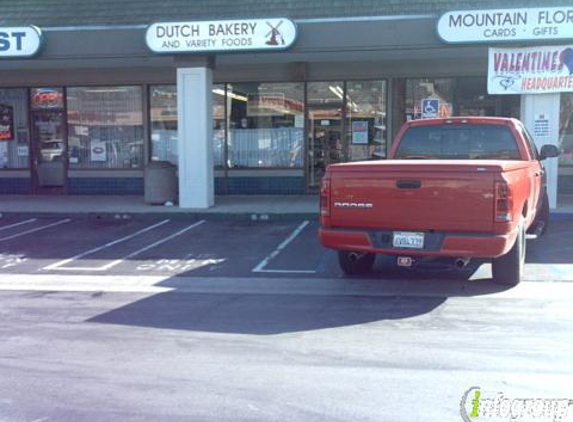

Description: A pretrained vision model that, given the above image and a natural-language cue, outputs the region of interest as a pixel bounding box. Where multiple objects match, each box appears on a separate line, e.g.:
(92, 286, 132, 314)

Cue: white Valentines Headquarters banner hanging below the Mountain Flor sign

(487, 45, 573, 94)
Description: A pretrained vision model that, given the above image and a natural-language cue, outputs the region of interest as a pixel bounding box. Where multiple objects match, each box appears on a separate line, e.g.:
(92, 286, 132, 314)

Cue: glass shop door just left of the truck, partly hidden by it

(307, 82, 346, 192)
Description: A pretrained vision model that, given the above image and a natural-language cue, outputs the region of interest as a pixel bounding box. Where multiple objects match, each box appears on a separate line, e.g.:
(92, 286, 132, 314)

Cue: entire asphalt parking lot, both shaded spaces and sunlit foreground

(0, 217, 573, 422)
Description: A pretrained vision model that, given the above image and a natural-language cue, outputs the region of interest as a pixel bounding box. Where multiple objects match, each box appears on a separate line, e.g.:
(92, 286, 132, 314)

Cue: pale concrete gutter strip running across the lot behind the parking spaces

(0, 274, 573, 301)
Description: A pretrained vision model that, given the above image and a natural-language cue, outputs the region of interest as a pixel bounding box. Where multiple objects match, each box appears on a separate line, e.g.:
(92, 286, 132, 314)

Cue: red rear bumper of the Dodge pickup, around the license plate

(319, 227, 517, 258)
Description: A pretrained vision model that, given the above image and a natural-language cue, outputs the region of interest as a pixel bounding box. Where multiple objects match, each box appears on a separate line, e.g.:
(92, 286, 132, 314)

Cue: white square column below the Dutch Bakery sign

(177, 67, 215, 209)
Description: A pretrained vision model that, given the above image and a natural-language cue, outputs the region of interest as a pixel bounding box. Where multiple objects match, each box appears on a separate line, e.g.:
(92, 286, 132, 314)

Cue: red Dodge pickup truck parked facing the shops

(319, 117, 559, 285)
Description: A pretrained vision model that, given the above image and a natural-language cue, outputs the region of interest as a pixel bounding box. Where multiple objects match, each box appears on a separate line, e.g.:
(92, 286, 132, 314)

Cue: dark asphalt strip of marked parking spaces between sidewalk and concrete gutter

(0, 217, 573, 282)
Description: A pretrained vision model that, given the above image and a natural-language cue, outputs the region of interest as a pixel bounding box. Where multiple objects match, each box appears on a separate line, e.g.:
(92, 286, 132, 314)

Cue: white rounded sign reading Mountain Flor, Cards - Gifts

(437, 6, 573, 43)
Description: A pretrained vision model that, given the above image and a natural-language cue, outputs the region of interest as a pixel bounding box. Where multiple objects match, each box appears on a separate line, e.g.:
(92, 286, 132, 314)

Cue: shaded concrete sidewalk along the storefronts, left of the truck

(0, 195, 318, 220)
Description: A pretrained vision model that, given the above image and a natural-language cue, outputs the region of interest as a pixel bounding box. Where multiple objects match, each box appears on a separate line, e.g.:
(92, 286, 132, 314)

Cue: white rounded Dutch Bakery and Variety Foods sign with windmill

(145, 18, 296, 53)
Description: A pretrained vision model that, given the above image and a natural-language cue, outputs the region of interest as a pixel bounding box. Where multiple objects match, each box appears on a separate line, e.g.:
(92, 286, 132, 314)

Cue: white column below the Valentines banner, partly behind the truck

(521, 94, 561, 208)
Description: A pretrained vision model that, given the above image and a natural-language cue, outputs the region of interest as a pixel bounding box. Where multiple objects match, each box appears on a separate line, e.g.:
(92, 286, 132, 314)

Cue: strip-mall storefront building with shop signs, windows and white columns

(0, 0, 573, 208)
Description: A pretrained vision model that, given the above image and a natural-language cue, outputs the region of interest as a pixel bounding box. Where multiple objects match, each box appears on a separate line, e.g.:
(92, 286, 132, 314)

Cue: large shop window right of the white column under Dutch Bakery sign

(227, 83, 304, 168)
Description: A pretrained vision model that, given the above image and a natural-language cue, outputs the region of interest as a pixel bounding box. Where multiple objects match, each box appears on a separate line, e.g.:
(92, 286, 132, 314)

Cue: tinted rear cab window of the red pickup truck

(394, 125, 521, 160)
